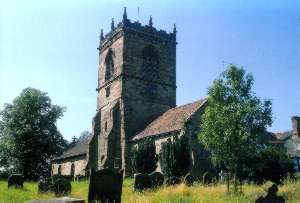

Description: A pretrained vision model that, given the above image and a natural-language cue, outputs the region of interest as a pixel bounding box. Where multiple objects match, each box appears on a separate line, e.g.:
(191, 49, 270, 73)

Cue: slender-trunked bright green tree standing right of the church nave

(199, 65, 272, 192)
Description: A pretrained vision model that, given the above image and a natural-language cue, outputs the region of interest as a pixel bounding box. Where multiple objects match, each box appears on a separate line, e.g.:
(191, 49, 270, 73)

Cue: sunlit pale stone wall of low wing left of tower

(52, 156, 87, 176)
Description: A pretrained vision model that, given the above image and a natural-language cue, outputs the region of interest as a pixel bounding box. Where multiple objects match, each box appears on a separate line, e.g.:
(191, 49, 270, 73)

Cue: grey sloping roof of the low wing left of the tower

(53, 137, 91, 161)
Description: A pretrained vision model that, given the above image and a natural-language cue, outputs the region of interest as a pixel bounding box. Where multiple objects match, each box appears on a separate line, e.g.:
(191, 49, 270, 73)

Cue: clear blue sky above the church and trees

(0, 0, 300, 139)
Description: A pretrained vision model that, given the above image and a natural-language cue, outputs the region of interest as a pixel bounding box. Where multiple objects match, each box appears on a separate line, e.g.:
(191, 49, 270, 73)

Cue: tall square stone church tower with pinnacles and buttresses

(88, 8, 177, 175)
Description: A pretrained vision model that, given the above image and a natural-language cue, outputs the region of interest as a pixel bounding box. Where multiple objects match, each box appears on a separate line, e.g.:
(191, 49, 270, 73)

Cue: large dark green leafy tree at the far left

(0, 88, 66, 180)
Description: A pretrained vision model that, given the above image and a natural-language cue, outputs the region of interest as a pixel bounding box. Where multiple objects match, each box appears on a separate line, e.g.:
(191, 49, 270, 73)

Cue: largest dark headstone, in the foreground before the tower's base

(88, 169, 123, 203)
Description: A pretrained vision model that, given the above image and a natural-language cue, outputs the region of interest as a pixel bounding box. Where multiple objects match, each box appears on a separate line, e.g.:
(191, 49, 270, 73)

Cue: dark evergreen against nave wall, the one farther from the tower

(159, 134, 190, 178)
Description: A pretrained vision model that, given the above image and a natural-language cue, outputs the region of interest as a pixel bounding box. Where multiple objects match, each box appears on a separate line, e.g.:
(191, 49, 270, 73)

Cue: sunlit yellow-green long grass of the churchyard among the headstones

(0, 179, 300, 203)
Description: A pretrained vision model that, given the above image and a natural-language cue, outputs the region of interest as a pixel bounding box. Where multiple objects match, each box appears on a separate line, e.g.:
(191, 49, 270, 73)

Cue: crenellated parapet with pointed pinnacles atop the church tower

(98, 7, 177, 51)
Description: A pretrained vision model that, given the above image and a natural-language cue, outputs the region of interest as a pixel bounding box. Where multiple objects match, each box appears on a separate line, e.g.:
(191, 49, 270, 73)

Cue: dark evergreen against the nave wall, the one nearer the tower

(132, 138, 158, 173)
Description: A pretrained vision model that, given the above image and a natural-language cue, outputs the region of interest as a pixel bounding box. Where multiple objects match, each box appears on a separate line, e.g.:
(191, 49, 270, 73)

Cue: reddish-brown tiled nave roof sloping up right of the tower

(132, 99, 207, 141)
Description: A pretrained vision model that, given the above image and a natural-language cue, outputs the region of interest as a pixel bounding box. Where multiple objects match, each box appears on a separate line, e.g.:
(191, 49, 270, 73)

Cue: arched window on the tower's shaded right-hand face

(141, 45, 159, 80)
